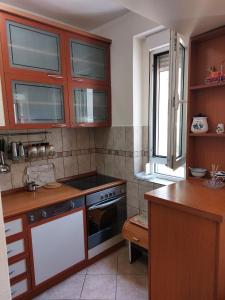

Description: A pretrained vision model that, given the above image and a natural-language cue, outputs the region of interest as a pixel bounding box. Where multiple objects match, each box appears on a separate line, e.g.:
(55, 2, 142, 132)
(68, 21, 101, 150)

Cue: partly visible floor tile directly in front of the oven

(87, 254, 117, 275)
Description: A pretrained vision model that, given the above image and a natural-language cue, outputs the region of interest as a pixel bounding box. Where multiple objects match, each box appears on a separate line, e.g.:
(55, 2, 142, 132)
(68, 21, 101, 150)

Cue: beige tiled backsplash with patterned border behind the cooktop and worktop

(0, 126, 162, 219)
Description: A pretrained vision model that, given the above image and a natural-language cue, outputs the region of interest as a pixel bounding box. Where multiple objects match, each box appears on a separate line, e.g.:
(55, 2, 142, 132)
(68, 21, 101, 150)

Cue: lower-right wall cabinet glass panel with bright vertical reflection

(73, 88, 108, 123)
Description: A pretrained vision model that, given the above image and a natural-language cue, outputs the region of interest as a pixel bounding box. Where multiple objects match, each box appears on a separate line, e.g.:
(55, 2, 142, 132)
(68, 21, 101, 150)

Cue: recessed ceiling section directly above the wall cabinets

(0, 0, 128, 30)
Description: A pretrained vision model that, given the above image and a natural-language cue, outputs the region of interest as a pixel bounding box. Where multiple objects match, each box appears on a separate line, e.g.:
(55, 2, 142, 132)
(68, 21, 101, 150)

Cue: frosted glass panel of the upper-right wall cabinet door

(71, 40, 105, 80)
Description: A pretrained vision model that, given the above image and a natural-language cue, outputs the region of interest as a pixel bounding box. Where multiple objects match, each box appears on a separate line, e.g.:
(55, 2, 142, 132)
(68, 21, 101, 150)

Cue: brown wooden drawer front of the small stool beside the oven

(123, 221, 148, 249)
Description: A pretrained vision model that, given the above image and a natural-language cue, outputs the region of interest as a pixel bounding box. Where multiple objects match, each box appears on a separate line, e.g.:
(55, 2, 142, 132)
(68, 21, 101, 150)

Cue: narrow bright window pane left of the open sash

(153, 52, 169, 157)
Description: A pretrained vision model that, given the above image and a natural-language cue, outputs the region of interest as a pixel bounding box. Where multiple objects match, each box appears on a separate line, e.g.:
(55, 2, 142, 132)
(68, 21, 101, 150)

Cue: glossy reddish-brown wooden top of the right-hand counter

(145, 179, 225, 222)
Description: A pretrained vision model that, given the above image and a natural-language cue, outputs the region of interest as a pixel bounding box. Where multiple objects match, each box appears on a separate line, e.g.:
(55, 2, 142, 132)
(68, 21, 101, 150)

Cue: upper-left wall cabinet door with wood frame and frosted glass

(3, 14, 64, 76)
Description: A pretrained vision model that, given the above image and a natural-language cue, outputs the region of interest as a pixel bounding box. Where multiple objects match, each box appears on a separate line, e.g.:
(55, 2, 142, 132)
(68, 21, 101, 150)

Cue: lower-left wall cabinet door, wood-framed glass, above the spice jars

(7, 76, 69, 128)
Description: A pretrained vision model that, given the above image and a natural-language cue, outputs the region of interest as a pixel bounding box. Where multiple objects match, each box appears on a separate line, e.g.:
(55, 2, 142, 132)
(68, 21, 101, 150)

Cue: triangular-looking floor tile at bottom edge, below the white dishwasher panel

(33, 274, 85, 300)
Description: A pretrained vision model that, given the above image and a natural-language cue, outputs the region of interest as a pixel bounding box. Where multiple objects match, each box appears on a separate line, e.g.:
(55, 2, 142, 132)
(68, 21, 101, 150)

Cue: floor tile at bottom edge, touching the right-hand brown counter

(81, 275, 116, 300)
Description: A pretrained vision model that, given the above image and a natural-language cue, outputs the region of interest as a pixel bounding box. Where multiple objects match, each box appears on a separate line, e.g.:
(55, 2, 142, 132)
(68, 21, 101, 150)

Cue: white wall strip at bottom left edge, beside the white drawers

(0, 193, 11, 300)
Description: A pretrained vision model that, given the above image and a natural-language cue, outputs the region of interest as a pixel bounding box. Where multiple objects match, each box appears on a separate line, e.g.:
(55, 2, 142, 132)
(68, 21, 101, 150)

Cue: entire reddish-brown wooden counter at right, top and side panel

(145, 179, 225, 300)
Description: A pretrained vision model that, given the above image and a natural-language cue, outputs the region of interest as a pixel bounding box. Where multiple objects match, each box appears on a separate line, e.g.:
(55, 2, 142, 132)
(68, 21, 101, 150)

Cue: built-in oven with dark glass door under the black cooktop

(86, 184, 127, 258)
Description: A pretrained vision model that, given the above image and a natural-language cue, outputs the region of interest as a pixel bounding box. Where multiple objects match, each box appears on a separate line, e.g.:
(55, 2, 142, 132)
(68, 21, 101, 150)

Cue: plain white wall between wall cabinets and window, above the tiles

(94, 12, 157, 126)
